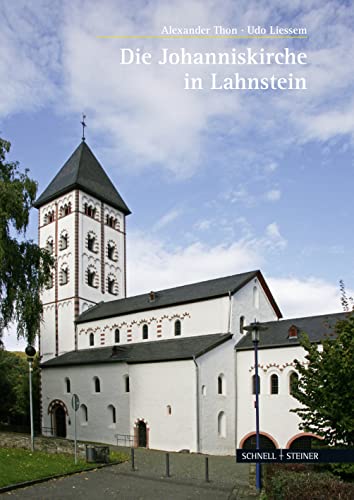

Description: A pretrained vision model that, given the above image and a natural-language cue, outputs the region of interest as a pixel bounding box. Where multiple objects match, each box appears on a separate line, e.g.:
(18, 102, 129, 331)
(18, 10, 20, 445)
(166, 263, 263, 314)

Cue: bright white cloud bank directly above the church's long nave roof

(128, 229, 346, 318)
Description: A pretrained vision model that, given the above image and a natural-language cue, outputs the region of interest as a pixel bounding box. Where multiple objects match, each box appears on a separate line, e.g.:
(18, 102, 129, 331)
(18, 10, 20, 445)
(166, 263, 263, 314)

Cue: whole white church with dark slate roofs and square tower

(35, 140, 344, 455)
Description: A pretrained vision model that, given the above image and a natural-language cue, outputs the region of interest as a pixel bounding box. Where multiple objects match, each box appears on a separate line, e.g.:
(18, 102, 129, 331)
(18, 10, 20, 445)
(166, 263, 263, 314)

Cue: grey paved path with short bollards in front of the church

(4, 449, 255, 500)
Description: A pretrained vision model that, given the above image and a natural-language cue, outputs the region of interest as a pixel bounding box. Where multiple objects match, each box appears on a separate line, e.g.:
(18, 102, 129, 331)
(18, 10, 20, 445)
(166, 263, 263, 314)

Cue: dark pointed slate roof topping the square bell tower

(33, 141, 131, 215)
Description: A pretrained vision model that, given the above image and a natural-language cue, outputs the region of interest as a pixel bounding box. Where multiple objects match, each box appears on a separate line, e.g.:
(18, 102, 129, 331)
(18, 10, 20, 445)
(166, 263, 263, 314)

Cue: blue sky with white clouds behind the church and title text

(0, 0, 354, 349)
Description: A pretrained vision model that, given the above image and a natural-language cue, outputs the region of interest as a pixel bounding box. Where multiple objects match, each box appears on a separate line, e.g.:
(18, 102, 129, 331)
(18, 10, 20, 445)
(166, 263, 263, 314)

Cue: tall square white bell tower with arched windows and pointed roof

(34, 138, 130, 361)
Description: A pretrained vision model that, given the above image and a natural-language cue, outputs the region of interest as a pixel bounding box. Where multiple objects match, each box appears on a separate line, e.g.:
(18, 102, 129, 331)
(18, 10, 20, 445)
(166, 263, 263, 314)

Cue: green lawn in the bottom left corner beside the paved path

(0, 448, 128, 488)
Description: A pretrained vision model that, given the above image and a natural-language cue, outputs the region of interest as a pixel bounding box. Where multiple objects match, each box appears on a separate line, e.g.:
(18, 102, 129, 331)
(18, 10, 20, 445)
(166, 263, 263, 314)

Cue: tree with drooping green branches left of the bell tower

(0, 138, 53, 344)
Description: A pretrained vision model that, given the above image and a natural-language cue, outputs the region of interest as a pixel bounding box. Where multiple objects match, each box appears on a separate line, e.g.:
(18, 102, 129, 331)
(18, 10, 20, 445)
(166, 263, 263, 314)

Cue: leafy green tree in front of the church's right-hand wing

(291, 313, 354, 447)
